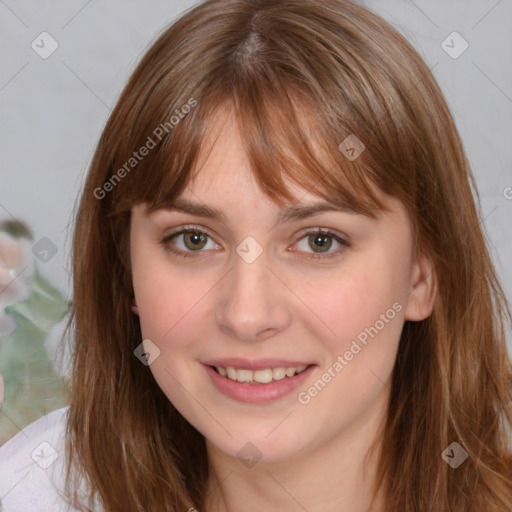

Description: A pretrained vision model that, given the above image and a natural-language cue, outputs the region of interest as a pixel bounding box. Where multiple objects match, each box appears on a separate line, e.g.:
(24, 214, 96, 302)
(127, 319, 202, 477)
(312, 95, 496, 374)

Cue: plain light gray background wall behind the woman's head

(0, 0, 512, 352)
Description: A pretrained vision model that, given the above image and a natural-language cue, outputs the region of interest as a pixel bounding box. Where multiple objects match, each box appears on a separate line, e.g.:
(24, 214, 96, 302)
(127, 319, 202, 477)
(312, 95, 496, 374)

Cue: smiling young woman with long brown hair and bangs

(2, 0, 512, 512)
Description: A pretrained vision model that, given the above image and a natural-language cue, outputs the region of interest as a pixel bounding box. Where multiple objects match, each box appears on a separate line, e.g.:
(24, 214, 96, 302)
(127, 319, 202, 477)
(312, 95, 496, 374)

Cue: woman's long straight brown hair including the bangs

(64, 0, 512, 512)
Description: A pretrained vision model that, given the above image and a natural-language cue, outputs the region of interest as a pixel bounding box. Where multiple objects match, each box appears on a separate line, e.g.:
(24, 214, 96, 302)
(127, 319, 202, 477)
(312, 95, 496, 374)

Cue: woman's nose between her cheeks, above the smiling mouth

(215, 249, 292, 341)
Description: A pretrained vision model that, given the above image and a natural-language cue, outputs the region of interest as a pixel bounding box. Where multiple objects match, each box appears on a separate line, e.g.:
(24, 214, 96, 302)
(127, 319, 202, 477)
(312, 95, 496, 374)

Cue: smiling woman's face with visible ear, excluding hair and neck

(131, 110, 433, 462)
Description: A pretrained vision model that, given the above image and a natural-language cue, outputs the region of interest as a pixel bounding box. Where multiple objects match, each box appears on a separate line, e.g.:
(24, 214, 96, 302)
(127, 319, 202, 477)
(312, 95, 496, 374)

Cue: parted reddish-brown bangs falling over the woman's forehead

(116, 76, 385, 217)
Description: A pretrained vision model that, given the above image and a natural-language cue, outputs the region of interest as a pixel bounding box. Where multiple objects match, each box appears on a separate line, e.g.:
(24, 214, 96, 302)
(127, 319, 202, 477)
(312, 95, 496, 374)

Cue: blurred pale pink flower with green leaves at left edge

(0, 220, 69, 444)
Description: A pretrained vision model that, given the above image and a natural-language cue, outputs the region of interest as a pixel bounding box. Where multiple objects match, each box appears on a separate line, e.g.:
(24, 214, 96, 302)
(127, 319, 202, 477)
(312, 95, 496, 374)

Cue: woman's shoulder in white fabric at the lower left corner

(0, 407, 85, 512)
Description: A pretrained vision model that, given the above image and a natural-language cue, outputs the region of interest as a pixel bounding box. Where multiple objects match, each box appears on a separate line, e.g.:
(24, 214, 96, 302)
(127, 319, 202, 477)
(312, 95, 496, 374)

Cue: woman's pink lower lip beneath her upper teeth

(203, 359, 316, 404)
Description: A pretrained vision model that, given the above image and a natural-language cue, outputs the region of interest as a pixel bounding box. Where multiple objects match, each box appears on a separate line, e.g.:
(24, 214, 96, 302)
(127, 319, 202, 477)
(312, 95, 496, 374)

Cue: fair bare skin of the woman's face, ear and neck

(131, 109, 435, 512)
